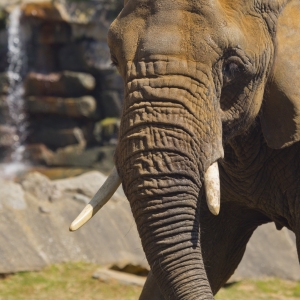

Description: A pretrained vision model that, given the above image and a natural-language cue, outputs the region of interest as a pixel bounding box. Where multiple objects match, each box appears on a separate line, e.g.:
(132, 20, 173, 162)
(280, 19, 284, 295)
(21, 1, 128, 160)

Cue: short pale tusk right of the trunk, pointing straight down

(204, 162, 220, 216)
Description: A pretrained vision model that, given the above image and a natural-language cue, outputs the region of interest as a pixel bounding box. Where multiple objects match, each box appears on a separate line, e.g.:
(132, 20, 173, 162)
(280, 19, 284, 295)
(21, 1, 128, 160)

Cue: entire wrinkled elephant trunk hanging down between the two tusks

(116, 70, 223, 300)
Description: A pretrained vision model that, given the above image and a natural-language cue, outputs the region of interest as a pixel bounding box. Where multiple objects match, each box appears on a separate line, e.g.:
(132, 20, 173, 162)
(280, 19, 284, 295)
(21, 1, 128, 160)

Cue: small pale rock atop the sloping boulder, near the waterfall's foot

(20, 172, 61, 201)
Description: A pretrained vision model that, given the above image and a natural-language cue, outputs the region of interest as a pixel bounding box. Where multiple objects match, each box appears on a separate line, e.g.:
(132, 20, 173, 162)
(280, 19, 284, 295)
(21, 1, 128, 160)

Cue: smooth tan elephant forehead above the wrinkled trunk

(108, 0, 266, 72)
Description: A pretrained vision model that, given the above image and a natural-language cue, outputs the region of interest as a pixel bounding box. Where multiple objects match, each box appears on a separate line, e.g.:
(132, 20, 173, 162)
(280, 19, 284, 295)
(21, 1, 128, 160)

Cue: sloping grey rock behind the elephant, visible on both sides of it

(0, 171, 300, 281)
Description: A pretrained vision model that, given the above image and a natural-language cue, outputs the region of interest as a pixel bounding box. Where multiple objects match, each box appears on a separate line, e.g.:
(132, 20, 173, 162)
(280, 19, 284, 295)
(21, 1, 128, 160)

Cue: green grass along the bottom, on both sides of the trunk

(0, 263, 300, 300)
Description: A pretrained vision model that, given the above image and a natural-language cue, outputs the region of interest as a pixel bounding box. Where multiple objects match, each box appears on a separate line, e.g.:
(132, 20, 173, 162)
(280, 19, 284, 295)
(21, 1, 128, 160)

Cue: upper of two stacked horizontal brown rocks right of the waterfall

(25, 71, 95, 97)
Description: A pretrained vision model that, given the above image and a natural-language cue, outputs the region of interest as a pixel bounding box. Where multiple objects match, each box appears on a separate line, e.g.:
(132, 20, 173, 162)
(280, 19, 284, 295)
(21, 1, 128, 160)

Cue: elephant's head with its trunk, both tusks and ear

(71, 0, 300, 300)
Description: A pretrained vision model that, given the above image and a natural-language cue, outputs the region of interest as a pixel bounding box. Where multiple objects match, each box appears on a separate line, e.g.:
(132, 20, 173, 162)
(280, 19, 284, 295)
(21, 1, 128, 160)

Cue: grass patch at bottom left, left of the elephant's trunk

(0, 263, 141, 300)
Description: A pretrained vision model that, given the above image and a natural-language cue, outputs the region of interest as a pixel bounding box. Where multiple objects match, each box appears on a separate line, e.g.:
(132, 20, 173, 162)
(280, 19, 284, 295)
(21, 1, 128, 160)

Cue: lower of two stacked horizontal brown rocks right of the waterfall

(26, 96, 96, 118)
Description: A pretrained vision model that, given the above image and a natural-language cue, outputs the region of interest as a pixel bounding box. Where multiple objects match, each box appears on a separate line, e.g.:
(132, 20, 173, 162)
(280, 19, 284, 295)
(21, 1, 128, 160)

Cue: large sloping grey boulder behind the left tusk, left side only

(0, 173, 147, 274)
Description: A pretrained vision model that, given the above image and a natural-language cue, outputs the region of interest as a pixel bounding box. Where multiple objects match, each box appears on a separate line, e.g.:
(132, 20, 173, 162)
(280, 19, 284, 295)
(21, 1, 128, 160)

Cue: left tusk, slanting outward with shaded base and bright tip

(70, 167, 121, 231)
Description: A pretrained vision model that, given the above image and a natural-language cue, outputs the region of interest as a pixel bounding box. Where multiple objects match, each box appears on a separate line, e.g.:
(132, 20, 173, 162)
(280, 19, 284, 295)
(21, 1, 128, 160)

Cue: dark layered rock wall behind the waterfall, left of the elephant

(0, 0, 123, 171)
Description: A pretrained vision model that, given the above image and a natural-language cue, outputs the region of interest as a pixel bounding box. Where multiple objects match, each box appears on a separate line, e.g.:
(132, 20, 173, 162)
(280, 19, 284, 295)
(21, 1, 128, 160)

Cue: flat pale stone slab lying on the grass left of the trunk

(93, 269, 146, 286)
